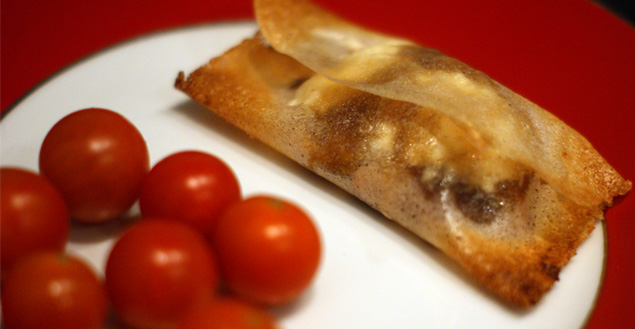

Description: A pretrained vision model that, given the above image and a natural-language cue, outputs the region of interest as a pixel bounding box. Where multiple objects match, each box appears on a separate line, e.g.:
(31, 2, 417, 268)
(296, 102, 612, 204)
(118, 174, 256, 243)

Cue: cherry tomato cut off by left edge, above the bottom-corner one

(0, 168, 70, 273)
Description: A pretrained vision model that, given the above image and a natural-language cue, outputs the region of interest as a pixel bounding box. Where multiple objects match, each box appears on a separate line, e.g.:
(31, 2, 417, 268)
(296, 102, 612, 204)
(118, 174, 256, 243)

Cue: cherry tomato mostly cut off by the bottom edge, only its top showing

(178, 297, 276, 329)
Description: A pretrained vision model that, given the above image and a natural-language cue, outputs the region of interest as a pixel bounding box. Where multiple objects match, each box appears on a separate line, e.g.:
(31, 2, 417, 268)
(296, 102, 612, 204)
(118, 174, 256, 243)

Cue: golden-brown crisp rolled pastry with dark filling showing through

(176, 0, 631, 306)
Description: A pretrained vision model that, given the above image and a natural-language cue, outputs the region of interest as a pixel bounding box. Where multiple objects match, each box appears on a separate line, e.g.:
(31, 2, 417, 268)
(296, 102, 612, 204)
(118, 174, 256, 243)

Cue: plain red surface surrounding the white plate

(1, 0, 635, 328)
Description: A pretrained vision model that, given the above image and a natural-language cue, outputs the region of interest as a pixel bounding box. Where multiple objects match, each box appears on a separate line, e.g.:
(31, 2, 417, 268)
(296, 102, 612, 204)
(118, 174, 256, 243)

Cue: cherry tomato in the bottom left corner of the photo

(2, 252, 107, 329)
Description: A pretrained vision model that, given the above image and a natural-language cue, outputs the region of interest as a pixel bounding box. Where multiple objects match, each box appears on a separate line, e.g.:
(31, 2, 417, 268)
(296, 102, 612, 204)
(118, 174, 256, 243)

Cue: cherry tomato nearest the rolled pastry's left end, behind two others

(139, 151, 241, 236)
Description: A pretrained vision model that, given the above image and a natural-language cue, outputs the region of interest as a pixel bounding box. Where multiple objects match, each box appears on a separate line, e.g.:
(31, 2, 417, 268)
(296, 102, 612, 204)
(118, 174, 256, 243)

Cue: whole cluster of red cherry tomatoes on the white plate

(0, 108, 321, 329)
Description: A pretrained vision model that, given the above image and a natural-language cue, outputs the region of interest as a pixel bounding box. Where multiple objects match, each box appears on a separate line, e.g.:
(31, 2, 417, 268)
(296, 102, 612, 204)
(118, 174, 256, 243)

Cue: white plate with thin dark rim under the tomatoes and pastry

(0, 22, 605, 329)
